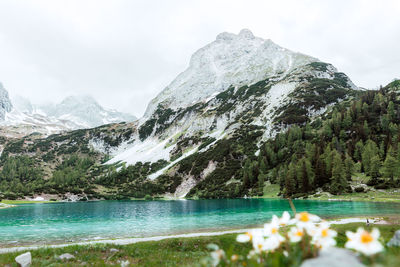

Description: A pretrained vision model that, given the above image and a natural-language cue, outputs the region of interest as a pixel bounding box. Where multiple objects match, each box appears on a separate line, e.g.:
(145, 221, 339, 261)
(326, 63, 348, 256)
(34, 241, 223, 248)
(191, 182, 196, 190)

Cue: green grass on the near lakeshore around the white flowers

(0, 223, 400, 267)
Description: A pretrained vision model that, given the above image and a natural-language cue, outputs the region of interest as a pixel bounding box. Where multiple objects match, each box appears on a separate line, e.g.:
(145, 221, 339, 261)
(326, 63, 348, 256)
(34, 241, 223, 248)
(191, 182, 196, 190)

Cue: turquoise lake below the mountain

(0, 199, 400, 247)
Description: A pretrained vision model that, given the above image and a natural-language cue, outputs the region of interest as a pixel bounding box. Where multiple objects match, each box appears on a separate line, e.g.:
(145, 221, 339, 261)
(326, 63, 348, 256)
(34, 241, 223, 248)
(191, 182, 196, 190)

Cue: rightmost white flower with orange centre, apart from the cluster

(345, 227, 383, 256)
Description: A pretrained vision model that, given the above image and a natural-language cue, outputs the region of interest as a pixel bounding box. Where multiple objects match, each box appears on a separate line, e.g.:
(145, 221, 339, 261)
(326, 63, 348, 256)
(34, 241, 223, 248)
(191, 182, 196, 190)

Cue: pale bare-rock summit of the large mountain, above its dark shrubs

(145, 29, 319, 118)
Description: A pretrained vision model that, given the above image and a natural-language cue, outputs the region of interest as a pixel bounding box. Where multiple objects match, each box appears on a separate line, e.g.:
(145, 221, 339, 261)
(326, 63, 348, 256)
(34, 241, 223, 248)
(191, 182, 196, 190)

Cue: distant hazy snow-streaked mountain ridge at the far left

(0, 84, 136, 136)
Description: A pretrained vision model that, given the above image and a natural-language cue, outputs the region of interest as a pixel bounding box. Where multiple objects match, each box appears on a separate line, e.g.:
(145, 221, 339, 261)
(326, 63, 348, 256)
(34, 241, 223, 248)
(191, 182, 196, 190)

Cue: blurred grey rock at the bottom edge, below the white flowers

(301, 248, 365, 267)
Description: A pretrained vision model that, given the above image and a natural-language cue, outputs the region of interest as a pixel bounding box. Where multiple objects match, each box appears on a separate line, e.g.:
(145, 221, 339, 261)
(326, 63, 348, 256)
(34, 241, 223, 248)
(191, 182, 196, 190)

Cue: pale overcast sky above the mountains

(0, 0, 400, 117)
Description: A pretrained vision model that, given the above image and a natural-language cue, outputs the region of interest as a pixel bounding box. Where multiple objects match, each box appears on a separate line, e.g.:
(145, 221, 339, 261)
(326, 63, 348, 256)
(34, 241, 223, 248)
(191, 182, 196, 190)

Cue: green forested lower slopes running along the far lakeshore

(0, 80, 400, 199)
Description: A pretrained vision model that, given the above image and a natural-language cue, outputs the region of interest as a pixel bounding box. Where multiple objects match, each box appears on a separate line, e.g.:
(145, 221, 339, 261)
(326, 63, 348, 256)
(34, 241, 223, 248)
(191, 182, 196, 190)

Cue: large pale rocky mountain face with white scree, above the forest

(100, 30, 357, 168)
